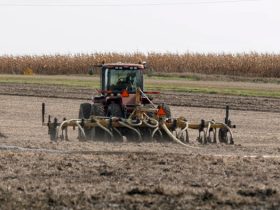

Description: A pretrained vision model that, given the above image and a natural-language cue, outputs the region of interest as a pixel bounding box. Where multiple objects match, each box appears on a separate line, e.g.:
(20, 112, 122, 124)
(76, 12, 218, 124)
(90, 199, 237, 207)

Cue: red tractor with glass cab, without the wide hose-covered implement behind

(79, 63, 171, 139)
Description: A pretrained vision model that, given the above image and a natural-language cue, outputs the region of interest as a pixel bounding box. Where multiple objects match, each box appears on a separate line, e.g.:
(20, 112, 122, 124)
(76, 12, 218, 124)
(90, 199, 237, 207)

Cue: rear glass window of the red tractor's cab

(106, 69, 142, 92)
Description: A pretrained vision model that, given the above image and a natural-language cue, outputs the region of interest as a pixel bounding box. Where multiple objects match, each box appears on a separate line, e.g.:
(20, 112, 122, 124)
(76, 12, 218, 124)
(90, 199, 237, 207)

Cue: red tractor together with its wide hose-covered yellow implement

(42, 63, 235, 146)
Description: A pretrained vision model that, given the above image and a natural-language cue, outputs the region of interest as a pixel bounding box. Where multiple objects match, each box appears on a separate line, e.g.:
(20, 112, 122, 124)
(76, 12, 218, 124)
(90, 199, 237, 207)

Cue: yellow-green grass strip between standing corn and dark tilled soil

(0, 75, 280, 98)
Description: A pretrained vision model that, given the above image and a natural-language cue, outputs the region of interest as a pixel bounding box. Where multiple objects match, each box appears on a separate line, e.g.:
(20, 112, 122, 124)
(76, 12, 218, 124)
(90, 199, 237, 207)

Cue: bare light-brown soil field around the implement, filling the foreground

(0, 95, 280, 209)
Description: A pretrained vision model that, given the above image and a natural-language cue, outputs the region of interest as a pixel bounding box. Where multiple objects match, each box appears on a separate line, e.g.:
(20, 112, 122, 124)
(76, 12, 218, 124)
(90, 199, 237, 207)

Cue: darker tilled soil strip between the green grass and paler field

(0, 84, 280, 113)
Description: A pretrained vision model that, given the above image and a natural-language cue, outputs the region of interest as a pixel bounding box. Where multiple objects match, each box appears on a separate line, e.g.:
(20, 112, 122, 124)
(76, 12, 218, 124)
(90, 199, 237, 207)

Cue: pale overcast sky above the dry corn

(0, 0, 280, 55)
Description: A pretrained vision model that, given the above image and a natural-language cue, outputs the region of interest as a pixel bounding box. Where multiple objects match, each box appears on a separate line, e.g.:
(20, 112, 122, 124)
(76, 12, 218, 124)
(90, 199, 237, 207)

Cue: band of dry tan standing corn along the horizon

(0, 53, 280, 78)
